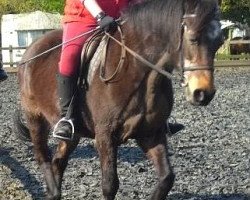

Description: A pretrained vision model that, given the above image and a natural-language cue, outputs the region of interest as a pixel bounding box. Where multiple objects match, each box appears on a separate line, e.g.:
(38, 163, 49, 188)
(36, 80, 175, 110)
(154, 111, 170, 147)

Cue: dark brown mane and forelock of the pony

(122, 0, 217, 51)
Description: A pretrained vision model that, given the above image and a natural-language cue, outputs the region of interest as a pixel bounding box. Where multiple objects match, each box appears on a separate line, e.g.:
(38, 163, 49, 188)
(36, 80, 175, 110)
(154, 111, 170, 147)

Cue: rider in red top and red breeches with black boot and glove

(53, 0, 135, 140)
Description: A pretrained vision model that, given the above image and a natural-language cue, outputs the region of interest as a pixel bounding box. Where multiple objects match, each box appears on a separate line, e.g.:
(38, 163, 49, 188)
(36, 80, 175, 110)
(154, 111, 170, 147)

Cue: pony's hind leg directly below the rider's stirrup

(52, 137, 80, 192)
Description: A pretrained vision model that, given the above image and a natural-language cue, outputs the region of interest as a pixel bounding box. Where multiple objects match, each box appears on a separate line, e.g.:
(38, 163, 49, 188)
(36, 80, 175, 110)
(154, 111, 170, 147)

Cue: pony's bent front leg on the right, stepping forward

(137, 131, 175, 200)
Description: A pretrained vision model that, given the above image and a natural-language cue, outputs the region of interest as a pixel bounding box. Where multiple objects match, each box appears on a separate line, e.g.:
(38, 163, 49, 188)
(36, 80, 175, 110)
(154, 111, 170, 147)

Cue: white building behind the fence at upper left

(0, 11, 61, 67)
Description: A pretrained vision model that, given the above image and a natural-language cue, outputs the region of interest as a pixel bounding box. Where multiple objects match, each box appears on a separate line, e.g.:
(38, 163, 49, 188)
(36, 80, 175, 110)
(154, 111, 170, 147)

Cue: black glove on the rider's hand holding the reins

(96, 13, 117, 32)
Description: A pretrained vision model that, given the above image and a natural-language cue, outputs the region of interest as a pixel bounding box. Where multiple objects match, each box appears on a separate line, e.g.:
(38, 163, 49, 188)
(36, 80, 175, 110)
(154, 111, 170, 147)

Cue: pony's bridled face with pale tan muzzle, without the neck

(179, 0, 223, 106)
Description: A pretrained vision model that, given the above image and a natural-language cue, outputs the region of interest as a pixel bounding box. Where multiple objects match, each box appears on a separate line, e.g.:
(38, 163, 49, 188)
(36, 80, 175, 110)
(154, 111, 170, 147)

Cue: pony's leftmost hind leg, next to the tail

(26, 114, 60, 199)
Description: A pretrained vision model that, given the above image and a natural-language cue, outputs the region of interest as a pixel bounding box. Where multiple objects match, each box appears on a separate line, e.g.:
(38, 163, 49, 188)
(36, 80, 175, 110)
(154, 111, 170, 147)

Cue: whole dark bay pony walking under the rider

(16, 0, 222, 200)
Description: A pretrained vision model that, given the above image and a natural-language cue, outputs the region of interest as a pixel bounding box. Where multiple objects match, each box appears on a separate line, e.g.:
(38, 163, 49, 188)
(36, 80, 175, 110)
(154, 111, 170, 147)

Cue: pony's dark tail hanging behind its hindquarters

(13, 109, 31, 142)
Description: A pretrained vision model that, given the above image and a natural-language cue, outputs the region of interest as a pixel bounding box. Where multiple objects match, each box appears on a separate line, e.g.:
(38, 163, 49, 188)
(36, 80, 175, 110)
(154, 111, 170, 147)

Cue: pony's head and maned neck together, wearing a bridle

(124, 0, 223, 105)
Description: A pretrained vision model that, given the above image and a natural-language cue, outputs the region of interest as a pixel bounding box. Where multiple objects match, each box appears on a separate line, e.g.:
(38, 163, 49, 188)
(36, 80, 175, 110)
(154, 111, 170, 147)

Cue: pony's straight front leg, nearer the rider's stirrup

(96, 133, 119, 200)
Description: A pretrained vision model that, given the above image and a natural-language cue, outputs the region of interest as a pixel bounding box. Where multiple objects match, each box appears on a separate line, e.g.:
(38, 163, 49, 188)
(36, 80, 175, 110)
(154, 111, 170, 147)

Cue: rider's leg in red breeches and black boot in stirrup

(53, 22, 93, 140)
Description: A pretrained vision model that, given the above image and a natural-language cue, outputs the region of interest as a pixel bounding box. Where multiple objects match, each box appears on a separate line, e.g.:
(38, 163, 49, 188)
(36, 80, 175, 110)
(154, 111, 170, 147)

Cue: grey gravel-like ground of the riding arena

(0, 67, 250, 200)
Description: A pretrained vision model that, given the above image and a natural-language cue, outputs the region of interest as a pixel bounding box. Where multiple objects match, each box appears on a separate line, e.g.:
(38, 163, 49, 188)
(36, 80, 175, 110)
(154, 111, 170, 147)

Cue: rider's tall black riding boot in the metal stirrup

(53, 74, 76, 140)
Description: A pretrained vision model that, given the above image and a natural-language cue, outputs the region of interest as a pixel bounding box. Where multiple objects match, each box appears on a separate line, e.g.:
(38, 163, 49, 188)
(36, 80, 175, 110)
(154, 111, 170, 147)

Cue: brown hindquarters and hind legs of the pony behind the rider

(16, 30, 79, 199)
